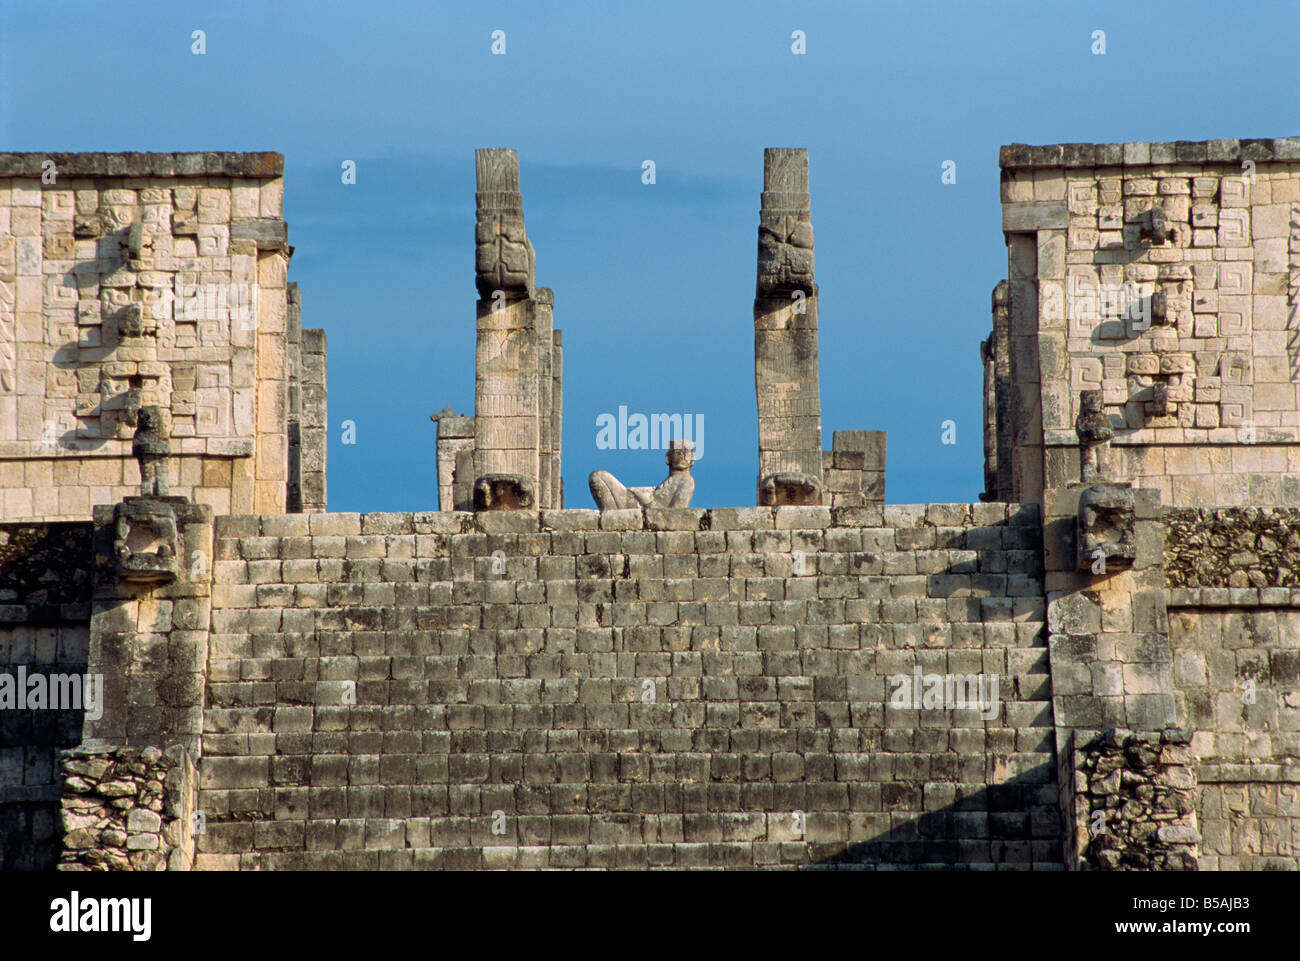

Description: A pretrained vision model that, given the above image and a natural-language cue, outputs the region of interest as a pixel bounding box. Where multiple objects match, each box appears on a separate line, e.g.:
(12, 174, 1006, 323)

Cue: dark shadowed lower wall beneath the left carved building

(0, 523, 91, 870)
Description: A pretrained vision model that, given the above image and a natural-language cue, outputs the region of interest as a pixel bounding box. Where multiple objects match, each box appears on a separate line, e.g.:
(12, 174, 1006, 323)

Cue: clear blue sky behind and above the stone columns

(0, 0, 1300, 511)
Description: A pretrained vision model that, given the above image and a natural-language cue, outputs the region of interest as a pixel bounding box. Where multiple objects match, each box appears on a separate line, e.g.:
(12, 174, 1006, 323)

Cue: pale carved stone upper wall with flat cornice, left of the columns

(0, 153, 306, 520)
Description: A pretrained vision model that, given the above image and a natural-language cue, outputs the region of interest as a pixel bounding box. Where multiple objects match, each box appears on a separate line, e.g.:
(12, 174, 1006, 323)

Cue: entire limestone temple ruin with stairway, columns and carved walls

(0, 138, 1300, 870)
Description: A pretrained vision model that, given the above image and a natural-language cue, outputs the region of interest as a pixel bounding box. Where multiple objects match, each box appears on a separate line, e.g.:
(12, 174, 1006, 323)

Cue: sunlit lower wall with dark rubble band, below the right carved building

(1165, 507, 1300, 870)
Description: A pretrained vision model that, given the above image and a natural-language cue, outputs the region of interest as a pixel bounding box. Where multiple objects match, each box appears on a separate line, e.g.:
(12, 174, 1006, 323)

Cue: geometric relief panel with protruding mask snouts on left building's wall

(0, 175, 260, 454)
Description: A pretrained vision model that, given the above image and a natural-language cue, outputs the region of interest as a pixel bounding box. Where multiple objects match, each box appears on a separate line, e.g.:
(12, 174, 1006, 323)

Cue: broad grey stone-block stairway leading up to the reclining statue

(185, 505, 1060, 869)
